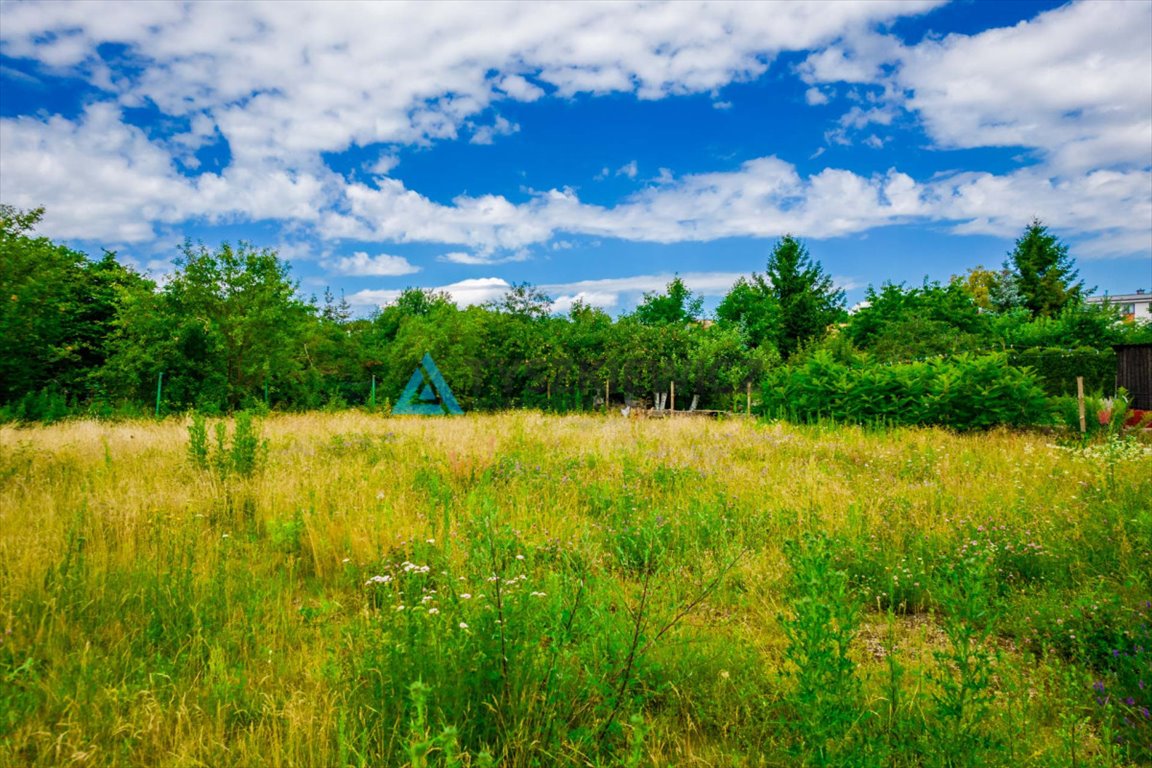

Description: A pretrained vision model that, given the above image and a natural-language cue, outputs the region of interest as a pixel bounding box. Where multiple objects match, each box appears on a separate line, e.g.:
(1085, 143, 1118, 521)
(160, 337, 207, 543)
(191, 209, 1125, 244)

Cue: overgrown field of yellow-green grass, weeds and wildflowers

(0, 412, 1152, 767)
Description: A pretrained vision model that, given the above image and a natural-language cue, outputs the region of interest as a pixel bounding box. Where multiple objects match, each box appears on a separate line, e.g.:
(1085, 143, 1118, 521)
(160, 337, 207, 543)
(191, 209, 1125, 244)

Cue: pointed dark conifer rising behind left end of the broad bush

(753, 235, 844, 359)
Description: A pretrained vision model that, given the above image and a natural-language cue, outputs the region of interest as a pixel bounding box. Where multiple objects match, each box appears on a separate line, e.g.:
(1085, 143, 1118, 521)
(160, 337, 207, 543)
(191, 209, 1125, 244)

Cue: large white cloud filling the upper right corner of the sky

(798, 0, 1152, 175)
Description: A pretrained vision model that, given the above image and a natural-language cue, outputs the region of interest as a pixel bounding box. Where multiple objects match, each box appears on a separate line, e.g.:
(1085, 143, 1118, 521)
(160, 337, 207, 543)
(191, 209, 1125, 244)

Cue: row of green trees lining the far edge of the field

(0, 206, 1152, 420)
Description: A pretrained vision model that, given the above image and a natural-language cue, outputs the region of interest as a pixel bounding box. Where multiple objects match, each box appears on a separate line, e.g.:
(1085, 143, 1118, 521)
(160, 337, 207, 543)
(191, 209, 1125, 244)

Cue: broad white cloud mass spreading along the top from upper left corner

(0, 0, 932, 164)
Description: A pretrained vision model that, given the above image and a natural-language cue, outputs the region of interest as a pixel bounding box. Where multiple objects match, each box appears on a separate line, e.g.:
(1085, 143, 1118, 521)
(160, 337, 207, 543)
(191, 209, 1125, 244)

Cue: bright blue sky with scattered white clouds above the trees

(0, 0, 1152, 313)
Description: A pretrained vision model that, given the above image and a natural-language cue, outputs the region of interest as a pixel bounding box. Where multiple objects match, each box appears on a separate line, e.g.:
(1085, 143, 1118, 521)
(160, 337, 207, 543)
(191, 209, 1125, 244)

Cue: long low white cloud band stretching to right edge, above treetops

(315, 149, 1152, 257)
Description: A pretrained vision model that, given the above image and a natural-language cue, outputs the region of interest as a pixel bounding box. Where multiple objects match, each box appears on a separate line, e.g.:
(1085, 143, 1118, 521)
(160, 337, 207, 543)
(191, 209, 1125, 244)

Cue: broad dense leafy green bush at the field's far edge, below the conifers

(761, 352, 1047, 429)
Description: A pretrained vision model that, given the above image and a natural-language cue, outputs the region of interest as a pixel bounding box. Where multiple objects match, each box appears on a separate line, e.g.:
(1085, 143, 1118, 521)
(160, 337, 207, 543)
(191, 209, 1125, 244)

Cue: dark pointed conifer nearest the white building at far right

(1005, 219, 1085, 318)
